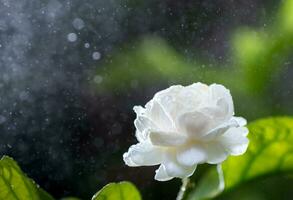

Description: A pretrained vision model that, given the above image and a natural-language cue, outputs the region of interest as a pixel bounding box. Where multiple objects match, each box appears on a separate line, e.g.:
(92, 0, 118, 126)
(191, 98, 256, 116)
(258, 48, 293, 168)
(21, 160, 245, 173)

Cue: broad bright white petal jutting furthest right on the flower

(219, 127, 249, 156)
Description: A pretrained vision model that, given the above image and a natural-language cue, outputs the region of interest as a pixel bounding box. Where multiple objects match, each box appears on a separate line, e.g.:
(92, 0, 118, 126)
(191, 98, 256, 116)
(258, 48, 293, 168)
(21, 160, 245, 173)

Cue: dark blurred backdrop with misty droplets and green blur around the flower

(0, 0, 293, 199)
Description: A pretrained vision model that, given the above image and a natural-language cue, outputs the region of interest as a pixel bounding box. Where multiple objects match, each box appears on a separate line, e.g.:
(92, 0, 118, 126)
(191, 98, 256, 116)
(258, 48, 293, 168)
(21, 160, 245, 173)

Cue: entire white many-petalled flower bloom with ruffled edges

(123, 83, 249, 181)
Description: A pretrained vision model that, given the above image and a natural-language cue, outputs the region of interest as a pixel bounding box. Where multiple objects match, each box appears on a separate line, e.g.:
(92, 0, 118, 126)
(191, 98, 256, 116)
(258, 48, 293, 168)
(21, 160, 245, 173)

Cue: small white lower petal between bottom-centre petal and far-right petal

(205, 142, 228, 164)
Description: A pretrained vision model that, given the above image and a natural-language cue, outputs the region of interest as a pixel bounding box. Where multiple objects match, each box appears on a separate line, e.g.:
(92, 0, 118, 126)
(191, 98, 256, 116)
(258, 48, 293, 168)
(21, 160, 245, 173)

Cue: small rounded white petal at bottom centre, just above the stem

(177, 147, 206, 166)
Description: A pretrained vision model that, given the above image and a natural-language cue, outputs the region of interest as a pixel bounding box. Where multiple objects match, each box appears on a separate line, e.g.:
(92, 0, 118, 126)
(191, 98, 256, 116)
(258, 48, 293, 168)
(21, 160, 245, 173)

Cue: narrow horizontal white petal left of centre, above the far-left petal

(149, 131, 188, 146)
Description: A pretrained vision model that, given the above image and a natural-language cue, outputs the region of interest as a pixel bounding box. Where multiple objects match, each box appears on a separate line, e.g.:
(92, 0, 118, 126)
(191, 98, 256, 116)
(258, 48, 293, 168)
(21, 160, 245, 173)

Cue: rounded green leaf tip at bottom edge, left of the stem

(92, 181, 141, 200)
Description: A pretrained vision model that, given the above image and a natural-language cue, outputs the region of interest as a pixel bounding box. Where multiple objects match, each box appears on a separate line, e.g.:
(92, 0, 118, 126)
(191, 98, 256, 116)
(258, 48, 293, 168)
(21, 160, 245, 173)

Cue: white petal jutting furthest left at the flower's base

(123, 143, 163, 167)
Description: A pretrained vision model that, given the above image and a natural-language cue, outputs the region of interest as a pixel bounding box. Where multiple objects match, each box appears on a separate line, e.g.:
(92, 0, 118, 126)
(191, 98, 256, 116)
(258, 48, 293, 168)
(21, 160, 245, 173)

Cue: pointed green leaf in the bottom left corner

(0, 156, 53, 200)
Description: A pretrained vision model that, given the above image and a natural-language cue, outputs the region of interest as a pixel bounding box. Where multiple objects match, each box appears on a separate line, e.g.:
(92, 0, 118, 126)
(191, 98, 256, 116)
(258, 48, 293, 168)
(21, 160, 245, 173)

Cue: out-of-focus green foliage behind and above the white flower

(97, 0, 293, 119)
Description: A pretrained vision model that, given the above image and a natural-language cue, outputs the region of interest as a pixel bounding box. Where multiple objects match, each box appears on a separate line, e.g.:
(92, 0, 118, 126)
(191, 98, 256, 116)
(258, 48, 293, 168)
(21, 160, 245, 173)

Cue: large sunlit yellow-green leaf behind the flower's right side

(188, 117, 293, 200)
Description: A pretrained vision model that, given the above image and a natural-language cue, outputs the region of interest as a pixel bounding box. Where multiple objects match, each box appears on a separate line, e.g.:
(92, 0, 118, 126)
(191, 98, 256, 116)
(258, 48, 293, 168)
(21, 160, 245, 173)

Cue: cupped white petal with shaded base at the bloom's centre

(178, 111, 213, 138)
